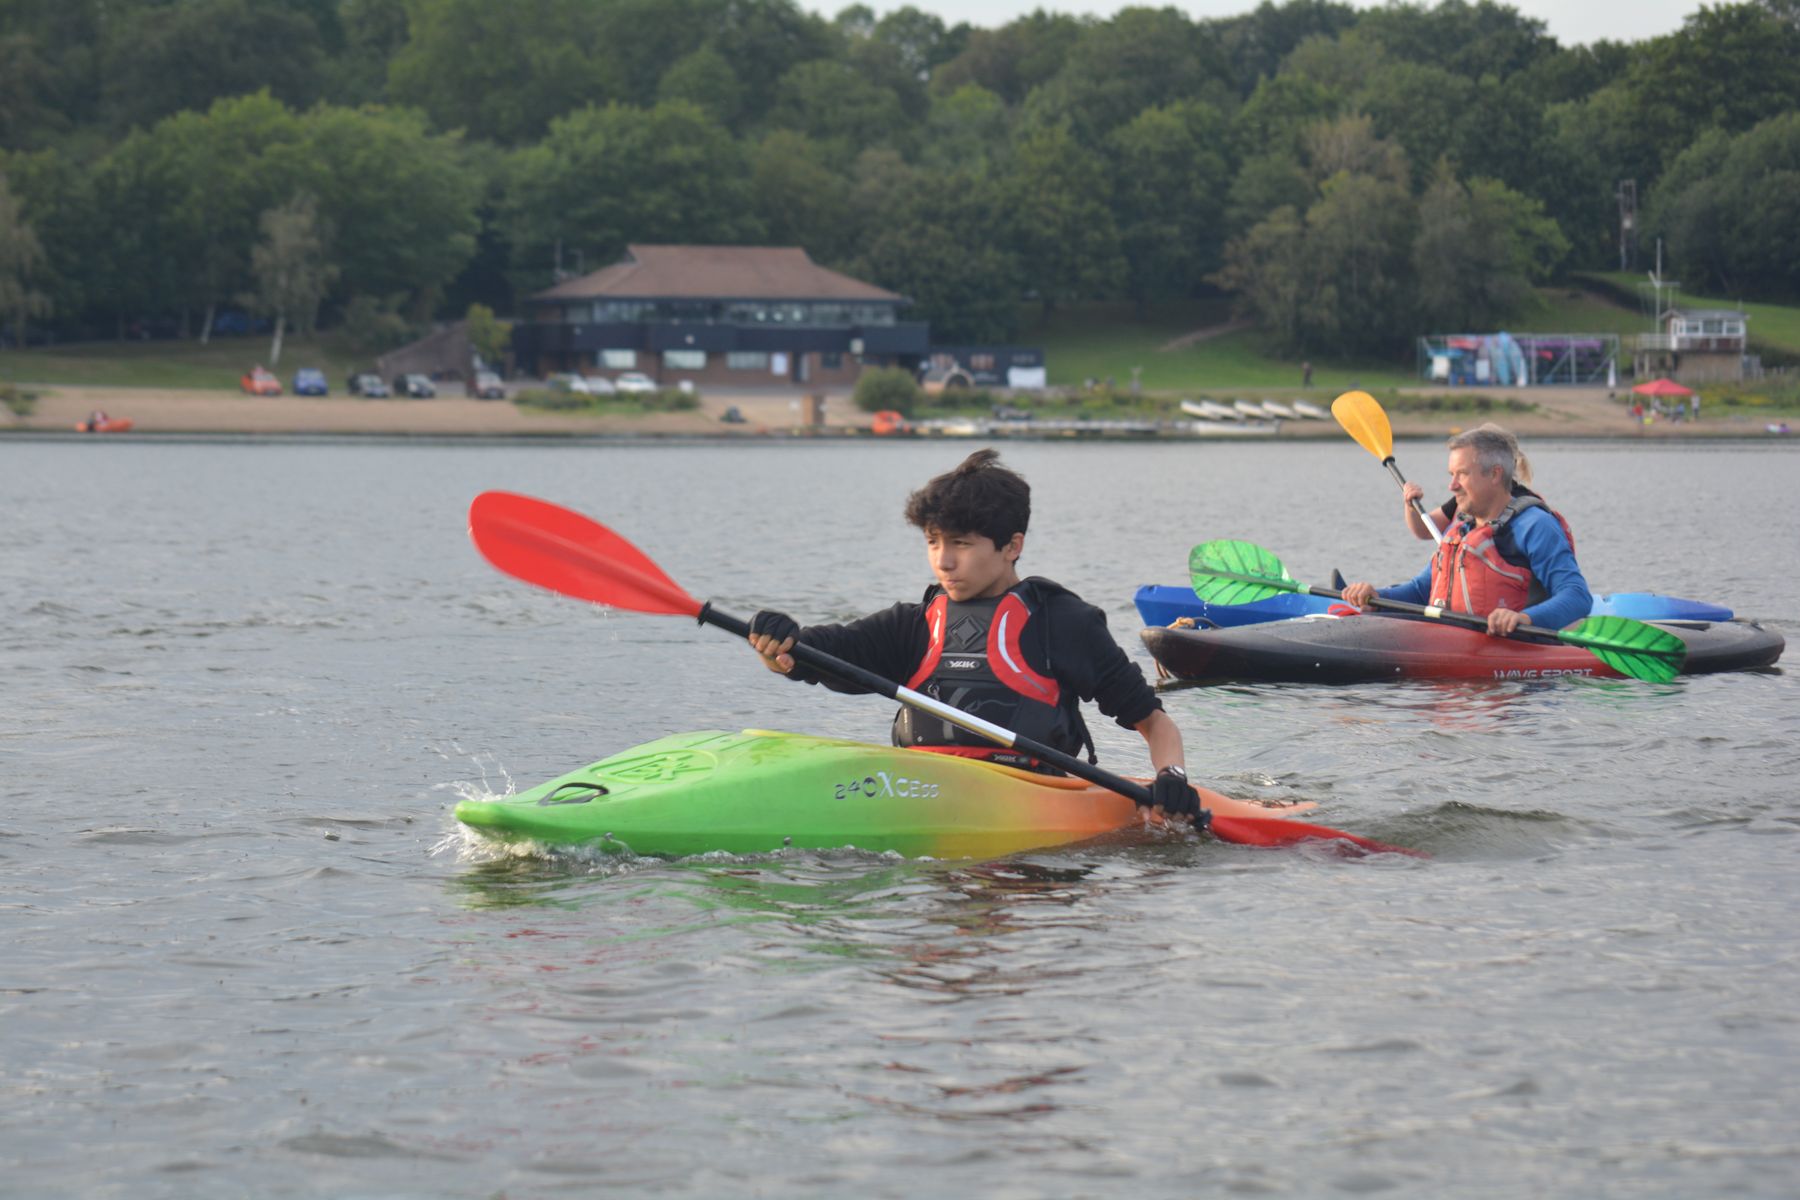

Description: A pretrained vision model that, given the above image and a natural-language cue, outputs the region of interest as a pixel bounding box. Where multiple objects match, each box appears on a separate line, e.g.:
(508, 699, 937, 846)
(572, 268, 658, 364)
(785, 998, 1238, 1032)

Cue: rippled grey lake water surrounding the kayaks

(0, 439, 1800, 1198)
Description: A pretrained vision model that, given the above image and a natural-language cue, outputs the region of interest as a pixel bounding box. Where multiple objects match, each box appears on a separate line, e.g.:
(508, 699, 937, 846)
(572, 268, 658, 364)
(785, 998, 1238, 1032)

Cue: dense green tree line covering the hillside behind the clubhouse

(0, 0, 1800, 354)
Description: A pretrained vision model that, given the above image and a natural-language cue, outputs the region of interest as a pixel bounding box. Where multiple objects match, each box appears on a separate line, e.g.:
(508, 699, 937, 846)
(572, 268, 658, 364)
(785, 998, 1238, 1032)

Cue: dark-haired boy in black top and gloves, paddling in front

(749, 450, 1201, 817)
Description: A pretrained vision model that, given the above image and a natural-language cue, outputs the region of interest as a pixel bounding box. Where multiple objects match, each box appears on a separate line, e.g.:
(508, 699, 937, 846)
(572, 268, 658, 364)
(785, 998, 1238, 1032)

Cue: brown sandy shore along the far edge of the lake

(0, 387, 1764, 439)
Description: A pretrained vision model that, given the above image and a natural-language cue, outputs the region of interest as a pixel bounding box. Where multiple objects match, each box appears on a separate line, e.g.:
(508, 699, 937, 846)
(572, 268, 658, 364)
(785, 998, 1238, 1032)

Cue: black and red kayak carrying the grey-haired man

(1141, 613, 1787, 684)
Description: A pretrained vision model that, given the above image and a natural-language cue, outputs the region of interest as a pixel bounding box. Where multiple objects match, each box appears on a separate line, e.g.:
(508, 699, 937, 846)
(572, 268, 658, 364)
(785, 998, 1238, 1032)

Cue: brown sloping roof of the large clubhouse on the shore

(531, 246, 905, 302)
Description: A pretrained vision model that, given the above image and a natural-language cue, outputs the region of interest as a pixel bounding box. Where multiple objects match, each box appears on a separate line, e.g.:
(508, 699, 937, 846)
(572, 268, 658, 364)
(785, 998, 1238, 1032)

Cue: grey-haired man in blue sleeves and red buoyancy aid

(1343, 426, 1593, 637)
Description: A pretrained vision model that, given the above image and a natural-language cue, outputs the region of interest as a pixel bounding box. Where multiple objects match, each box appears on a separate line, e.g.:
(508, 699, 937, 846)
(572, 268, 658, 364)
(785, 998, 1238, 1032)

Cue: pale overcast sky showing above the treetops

(817, 0, 1701, 45)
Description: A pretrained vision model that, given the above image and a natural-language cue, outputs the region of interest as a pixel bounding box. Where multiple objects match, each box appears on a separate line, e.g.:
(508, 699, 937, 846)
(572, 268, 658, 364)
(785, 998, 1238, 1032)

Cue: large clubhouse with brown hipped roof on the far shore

(513, 246, 931, 387)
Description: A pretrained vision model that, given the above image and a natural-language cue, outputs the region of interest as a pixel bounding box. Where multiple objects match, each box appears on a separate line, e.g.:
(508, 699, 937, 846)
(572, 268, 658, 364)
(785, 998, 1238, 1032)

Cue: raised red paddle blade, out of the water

(468, 491, 700, 617)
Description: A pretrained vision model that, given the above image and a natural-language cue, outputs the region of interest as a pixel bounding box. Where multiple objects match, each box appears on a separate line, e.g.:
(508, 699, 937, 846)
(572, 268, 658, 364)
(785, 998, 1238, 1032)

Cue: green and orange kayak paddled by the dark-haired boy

(455, 729, 1314, 858)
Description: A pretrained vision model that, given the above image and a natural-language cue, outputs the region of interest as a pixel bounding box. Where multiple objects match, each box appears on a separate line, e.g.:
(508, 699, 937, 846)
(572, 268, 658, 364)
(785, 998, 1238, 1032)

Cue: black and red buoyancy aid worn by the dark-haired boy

(893, 578, 1093, 766)
